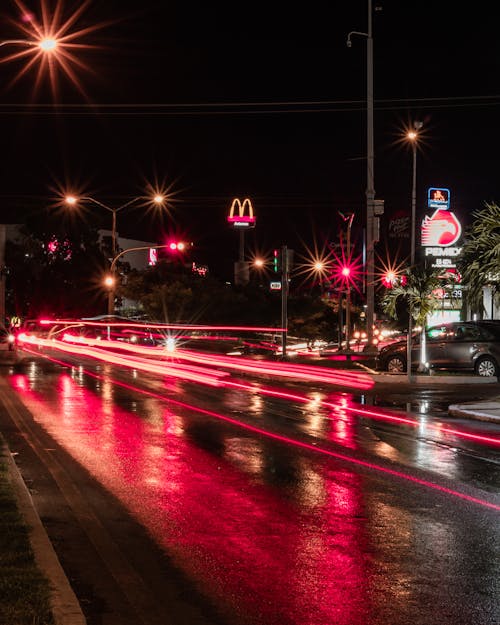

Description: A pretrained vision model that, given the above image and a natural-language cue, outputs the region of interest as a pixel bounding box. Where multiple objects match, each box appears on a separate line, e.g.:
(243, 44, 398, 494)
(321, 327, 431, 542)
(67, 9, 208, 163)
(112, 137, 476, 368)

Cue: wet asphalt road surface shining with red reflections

(1, 352, 500, 625)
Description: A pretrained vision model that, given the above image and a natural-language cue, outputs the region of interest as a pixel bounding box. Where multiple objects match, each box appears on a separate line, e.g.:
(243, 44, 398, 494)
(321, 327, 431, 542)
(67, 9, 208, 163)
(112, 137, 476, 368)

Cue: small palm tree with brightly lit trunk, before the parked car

(380, 267, 443, 375)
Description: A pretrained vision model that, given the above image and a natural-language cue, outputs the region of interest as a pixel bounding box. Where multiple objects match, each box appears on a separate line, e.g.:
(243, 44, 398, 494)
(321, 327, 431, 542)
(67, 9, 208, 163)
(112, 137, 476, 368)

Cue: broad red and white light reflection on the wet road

(4, 358, 500, 625)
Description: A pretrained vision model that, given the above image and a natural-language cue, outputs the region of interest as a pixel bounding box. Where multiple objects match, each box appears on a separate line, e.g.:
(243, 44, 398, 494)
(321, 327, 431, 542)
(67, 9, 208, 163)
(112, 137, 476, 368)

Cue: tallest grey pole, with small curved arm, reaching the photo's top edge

(347, 0, 375, 348)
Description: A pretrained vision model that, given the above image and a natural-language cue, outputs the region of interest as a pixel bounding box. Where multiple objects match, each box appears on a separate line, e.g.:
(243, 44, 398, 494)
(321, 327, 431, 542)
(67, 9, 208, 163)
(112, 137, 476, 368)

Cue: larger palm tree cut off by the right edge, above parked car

(457, 203, 500, 314)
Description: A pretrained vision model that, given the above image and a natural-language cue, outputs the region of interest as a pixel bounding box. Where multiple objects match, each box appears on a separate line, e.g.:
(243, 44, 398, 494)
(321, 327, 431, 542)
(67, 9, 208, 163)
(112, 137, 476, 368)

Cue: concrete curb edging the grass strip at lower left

(0, 434, 87, 625)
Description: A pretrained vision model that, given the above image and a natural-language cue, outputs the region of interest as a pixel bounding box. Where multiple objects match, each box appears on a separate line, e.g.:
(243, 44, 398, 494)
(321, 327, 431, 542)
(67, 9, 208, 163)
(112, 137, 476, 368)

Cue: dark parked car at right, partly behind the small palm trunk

(376, 320, 500, 377)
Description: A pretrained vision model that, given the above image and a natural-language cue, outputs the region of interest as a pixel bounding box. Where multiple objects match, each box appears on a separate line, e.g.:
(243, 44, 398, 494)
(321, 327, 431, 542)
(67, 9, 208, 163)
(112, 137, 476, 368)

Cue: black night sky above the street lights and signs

(0, 0, 500, 276)
